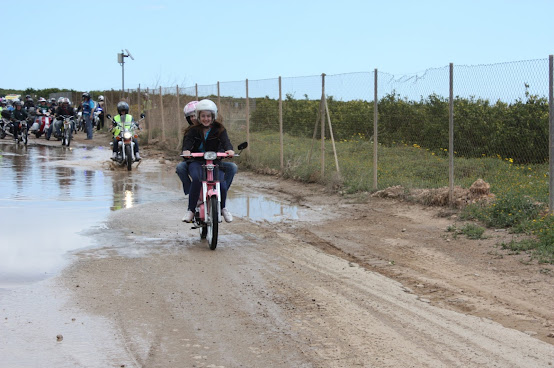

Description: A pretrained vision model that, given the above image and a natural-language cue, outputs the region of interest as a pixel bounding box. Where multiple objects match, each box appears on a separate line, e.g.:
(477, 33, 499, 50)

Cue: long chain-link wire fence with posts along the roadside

(96, 59, 550, 207)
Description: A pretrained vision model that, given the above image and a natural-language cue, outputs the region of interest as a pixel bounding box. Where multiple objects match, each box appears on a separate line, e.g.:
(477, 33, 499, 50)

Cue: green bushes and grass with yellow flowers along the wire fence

(226, 90, 554, 264)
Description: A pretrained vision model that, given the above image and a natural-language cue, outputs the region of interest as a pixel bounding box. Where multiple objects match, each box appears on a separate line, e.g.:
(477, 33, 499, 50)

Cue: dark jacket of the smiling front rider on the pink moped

(182, 121, 233, 160)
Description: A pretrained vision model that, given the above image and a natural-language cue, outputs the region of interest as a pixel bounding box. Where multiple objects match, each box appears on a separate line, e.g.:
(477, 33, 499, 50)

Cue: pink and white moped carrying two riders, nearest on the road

(181, 142, 248, 250)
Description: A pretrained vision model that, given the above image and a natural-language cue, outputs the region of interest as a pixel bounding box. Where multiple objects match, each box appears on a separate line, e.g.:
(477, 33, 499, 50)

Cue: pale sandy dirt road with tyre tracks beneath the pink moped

(0, 134, 554, 367)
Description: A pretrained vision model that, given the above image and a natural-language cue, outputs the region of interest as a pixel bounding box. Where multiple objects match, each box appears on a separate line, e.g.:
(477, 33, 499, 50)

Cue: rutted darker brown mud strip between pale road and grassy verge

(281, 216, 552, 344)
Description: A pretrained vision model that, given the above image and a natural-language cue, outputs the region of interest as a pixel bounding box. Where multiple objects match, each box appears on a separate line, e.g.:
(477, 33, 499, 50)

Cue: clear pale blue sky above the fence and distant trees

(4, 0, 554, 91)
